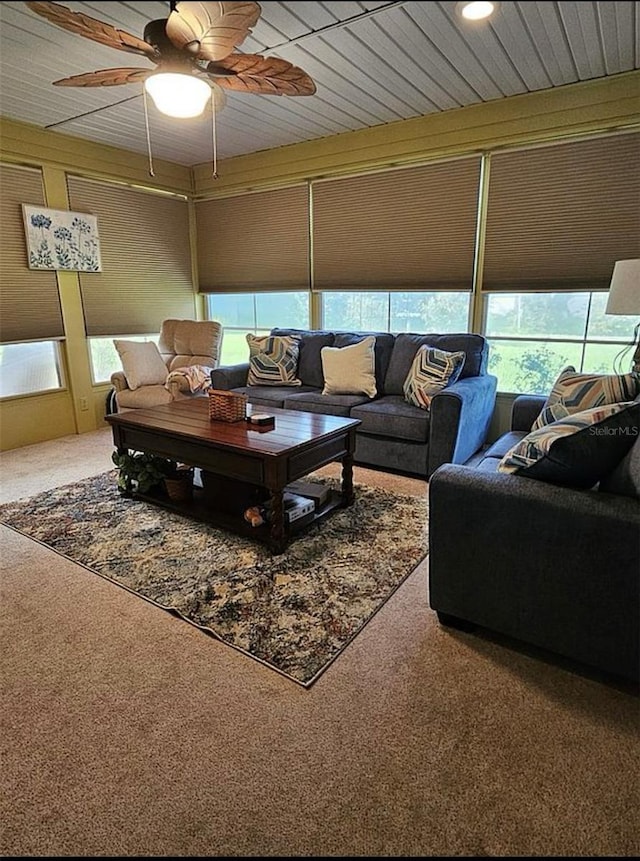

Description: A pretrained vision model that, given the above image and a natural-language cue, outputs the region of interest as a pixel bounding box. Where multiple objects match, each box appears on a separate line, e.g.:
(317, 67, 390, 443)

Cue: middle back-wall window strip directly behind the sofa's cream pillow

(322, 290, 471, 333)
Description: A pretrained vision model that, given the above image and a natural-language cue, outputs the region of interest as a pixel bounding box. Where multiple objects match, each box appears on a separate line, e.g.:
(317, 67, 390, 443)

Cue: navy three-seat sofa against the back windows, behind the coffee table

(211, 328, 497, 478)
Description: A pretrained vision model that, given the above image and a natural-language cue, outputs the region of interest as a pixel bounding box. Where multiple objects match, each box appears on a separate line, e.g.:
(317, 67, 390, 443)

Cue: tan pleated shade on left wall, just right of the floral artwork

(67, 177, 195, 335)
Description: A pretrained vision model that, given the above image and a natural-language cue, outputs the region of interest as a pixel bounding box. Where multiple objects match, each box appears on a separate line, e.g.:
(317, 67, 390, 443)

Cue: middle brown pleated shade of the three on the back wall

(312, 157, 480, 290)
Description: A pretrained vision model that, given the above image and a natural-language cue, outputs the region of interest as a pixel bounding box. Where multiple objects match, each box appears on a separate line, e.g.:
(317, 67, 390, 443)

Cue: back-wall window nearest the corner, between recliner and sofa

(207, 290, 309, 365)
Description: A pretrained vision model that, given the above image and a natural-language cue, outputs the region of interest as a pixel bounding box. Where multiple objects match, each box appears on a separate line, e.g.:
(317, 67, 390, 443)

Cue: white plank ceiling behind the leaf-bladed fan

(0, 0, 640, 165)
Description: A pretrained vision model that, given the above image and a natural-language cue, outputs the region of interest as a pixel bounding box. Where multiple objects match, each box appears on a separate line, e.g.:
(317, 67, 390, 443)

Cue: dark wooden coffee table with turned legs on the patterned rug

(105, 398, 360, 553)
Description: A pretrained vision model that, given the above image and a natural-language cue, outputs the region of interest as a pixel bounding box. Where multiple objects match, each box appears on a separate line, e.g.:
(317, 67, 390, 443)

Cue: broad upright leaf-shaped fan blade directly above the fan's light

(166, 2, 261, 60)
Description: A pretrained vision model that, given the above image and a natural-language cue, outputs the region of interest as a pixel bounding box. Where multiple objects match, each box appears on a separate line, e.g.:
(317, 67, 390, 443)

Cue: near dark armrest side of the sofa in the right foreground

(429, 464, 640, 677)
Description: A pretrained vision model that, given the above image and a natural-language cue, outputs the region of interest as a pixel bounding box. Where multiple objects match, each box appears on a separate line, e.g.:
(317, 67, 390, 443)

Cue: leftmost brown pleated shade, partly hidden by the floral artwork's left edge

(0, 165, 64, 344)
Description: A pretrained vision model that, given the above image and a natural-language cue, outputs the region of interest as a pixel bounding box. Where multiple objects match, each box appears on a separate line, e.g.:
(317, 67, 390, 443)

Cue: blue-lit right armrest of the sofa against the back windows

(427, 374, 498, 478)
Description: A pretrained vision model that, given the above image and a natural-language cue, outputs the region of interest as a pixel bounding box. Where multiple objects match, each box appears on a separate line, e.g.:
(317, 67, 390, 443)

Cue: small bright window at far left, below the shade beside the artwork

(0, 341, 62, 398)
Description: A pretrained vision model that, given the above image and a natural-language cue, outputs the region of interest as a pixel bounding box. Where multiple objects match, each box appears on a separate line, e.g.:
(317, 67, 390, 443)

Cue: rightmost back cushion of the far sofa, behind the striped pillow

(384, 332, 489, 395)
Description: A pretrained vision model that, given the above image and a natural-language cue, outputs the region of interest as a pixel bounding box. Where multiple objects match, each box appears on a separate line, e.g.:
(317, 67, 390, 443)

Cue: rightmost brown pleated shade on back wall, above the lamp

(483, 133, 640, 291)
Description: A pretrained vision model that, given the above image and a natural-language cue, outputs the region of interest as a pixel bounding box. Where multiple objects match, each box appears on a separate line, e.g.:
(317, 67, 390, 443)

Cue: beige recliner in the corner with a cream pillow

(111, 319, 222, 410)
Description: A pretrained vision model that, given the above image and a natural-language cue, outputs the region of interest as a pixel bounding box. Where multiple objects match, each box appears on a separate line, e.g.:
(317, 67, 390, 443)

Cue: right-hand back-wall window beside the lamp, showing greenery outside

(485, 292, 636, 394)
